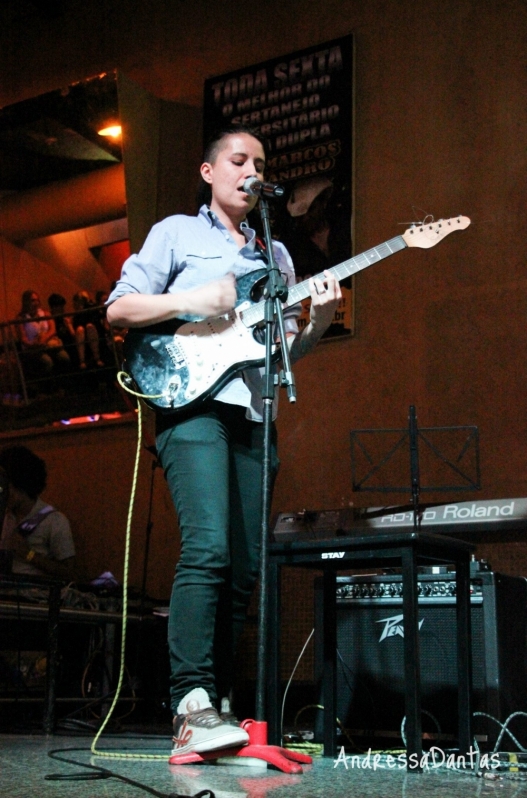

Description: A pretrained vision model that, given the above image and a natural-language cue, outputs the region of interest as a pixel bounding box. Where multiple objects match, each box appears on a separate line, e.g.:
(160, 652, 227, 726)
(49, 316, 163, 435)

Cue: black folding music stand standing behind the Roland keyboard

(351, 405, 481, 530)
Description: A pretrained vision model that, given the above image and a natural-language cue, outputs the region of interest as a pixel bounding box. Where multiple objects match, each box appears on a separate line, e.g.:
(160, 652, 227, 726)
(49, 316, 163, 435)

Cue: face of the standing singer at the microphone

(201, 133, 265, 220)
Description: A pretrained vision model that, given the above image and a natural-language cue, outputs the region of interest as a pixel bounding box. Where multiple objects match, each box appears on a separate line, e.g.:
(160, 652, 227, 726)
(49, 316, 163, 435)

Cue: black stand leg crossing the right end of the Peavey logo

(401, 546, 422, 773)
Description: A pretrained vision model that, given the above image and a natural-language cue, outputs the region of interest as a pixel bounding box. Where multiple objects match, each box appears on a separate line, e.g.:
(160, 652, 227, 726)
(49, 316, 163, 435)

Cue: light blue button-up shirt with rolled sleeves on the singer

(108, 205, 301, 421)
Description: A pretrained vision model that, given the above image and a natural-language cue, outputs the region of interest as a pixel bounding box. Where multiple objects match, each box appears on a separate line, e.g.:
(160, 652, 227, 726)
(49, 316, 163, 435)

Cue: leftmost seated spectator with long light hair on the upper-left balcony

(17, 291, 70, 374)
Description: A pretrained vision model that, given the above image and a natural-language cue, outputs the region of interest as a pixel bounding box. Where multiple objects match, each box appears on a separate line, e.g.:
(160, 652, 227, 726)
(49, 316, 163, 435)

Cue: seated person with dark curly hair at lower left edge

(0, 446, 75, 580)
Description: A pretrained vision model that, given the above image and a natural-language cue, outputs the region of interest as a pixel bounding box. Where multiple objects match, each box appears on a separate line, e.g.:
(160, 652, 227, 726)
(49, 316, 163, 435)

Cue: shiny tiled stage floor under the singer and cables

(0, 733, 527, 798)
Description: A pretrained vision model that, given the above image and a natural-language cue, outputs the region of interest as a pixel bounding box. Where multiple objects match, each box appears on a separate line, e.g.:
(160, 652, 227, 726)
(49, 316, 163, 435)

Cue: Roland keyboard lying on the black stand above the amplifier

(273, 499, 527, 543)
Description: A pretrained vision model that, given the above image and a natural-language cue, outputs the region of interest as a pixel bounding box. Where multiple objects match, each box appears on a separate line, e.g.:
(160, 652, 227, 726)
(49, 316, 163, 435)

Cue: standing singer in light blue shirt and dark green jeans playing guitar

(108, 126, 341, 754)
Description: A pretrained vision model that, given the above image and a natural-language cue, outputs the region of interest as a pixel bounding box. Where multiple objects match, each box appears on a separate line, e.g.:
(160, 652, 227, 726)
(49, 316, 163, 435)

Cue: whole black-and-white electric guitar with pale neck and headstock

(123, 216, 470, 413)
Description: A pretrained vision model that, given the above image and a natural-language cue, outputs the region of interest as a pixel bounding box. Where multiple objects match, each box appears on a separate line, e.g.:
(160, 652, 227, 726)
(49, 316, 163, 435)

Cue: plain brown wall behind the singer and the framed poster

(0, 0, 527, 676)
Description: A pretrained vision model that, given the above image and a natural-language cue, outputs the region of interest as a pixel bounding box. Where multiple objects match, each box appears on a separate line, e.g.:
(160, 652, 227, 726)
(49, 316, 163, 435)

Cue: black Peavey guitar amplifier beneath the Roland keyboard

(315, 569, 527, 741)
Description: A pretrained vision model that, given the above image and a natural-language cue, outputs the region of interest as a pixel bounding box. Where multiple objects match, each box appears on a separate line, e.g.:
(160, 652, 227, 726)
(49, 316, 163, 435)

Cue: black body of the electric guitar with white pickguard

(124, 269, 279, 413)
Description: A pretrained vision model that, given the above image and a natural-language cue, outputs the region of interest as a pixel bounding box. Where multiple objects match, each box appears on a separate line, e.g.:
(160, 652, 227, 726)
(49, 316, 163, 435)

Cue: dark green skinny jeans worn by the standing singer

(157, 401, 278, 714)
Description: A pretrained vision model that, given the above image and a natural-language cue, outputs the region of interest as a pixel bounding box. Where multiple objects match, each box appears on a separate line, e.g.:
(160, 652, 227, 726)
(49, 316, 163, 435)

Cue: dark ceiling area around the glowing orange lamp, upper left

(0, 72, 121, 192)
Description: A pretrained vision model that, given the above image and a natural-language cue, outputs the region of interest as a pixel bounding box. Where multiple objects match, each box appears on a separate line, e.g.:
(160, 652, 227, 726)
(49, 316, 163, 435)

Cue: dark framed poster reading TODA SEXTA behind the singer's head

(204, 35, 354, 338)
